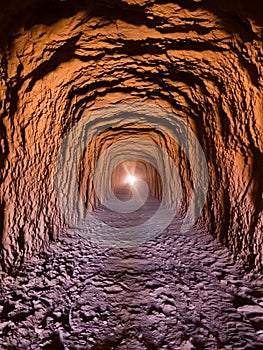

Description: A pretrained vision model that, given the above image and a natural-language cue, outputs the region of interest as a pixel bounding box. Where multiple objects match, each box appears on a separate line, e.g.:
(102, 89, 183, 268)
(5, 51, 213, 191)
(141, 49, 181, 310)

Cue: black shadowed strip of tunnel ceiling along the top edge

(0, 0, 263, 49)
